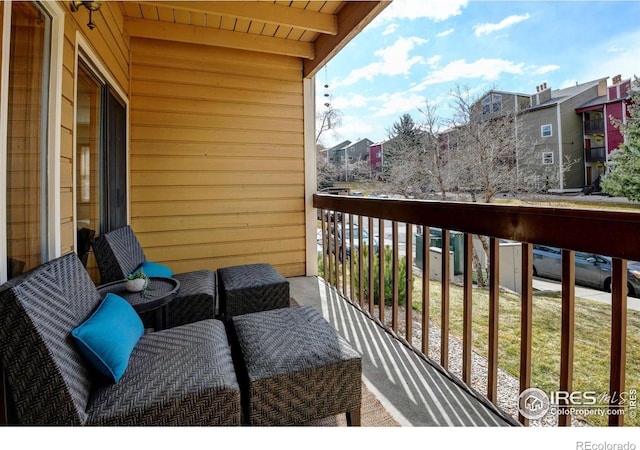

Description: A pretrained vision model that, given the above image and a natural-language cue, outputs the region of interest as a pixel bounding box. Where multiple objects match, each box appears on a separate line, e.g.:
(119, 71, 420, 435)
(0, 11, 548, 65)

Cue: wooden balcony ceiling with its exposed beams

(120, 0, 391, 77)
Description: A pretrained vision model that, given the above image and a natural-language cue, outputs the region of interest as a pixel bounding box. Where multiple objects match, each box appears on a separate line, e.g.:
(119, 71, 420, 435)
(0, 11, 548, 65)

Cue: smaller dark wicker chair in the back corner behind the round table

(91, 225, 217, 328)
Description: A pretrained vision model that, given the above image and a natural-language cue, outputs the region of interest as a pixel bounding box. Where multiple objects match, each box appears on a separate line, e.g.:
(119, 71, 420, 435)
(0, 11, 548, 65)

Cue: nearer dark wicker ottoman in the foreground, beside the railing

(233, 306, 362, 426)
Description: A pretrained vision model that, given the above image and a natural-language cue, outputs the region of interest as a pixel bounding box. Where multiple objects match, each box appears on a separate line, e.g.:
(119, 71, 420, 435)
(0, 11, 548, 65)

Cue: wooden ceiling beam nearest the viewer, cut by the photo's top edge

(145, 1, 338, 35)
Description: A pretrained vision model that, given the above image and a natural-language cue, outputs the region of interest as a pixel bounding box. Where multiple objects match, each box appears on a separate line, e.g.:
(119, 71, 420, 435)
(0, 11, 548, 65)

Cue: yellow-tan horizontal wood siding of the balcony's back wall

(130, 38, 305, 276)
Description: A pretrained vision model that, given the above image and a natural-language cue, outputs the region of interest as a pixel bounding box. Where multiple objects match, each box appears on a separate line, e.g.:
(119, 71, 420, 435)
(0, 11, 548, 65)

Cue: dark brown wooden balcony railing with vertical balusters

(313, 194, 640, 426)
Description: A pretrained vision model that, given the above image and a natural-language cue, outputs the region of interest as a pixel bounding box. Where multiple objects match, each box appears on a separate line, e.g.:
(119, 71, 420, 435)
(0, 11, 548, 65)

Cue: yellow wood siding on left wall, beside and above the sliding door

(60, 2, 130, 274)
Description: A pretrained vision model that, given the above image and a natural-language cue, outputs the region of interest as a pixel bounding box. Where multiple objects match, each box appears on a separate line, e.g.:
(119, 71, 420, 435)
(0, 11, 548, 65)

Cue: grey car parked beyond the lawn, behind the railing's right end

(533, 245, 640, 297)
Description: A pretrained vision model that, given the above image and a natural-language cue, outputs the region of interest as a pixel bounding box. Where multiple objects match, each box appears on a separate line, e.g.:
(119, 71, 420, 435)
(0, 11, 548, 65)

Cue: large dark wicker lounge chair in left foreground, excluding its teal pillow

(0, 253, 241, 426)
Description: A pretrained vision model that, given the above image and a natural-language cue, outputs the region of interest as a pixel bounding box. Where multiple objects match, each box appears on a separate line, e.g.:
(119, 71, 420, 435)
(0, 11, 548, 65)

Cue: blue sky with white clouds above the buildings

(316, 0, 640, 147)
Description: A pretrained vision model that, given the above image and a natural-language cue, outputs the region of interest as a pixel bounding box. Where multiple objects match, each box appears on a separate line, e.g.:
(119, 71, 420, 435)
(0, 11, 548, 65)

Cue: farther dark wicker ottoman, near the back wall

(218, 264, 290, 320)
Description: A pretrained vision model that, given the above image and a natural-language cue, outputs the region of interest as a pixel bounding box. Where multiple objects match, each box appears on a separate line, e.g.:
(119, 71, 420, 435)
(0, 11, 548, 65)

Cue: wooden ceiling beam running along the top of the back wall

(124, 17, 315, 59)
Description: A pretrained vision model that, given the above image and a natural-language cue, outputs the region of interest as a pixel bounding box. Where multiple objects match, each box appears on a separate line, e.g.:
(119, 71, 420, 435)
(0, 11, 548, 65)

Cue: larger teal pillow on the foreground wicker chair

(71, 293, 144, 382)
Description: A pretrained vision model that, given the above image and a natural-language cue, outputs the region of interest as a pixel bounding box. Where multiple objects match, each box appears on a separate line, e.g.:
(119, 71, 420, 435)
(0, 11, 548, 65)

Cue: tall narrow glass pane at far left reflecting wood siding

(6, 2, 51, 278)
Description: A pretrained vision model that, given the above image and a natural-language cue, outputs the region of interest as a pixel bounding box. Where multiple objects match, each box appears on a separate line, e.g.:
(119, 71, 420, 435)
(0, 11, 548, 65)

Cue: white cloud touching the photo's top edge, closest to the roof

(376, 0, 469, 22)
